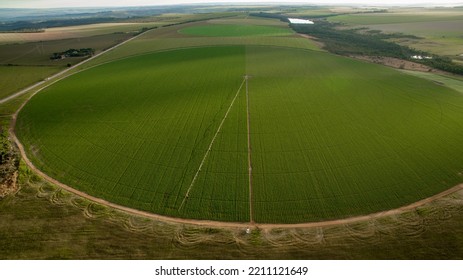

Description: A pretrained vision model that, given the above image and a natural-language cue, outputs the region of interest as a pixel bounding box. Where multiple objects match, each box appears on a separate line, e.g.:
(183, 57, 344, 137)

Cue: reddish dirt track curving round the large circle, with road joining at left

(6, 29, 463, 229)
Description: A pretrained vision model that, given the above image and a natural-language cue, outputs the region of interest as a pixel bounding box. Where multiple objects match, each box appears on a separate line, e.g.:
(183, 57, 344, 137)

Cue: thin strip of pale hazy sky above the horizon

(0, 0, 463, 8)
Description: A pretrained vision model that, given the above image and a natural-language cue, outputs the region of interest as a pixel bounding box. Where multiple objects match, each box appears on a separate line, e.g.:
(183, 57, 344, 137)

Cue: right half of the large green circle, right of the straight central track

(247, 48, 463, 222)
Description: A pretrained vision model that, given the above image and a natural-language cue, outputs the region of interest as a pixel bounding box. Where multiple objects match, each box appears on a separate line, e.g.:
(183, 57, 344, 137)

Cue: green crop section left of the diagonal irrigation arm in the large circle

(18, 47, 247, 220)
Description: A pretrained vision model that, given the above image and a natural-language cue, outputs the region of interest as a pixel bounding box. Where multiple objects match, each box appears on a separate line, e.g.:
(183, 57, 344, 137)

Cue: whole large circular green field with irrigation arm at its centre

(16, 46, 463, 223)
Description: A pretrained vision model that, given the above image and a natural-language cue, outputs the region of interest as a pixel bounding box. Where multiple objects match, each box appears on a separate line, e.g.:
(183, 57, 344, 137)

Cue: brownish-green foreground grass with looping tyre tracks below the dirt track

(0, 165, 463, 259)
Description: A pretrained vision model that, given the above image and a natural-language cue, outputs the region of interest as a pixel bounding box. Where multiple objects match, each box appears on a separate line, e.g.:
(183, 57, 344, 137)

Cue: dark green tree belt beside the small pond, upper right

(291, 21, 463, 74)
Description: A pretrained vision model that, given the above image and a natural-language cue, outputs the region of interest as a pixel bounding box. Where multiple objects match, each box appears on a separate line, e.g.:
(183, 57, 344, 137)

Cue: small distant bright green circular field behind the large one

(179, 24, 294, 37)
